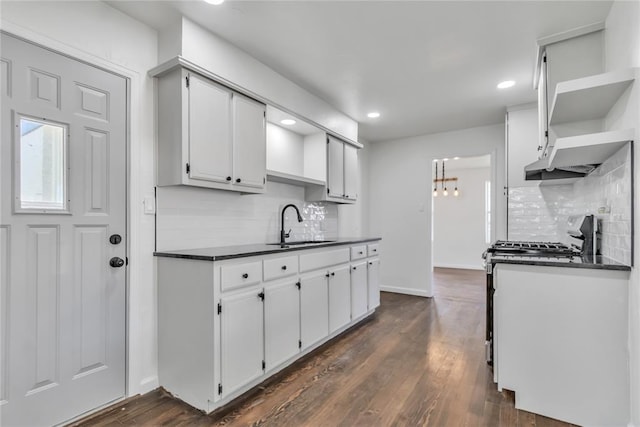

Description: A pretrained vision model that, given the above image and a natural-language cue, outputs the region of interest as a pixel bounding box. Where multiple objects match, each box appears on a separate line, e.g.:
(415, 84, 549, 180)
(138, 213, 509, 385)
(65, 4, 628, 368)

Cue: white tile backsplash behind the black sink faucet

(157, 182, 338, 250)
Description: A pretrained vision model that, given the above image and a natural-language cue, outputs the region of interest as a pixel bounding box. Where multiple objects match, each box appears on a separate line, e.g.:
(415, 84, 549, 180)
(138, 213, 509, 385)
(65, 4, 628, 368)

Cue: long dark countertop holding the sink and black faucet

(153, 237, 381, 261)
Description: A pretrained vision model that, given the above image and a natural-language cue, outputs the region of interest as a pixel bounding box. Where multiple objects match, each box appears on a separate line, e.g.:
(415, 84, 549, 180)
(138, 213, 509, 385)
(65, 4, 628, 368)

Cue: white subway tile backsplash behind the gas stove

(508, 146, 633, 265)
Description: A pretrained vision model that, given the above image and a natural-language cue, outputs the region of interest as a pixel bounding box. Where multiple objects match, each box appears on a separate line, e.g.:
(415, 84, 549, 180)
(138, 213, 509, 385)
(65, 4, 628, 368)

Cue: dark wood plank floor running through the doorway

(75, 269, 569, 426)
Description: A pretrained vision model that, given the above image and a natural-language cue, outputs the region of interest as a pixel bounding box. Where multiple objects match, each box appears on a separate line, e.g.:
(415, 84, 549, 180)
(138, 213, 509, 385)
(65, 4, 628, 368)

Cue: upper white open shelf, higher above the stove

(549, 68, 637, 125)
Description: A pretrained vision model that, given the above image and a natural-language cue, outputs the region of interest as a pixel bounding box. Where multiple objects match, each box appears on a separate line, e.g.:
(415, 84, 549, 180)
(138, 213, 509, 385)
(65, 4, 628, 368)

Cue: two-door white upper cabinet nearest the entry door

(158, 68, 266, 193)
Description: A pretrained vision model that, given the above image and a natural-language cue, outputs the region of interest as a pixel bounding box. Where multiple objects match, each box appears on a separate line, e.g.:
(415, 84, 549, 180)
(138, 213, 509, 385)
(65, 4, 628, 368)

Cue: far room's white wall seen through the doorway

(432, 167, 491, 270)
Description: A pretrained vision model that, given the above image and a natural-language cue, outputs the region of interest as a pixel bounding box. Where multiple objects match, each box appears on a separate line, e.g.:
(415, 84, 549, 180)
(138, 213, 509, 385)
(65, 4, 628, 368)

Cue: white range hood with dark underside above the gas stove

(524, 129, 634, 180)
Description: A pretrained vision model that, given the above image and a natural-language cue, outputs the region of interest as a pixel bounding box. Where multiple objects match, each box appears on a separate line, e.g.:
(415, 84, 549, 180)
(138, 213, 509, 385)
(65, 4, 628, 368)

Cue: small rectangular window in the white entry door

(16, 115, 68, 213)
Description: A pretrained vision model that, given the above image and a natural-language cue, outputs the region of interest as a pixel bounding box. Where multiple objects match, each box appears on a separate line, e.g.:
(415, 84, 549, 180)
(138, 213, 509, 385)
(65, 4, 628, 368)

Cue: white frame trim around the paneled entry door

(0, 20, 142, 402)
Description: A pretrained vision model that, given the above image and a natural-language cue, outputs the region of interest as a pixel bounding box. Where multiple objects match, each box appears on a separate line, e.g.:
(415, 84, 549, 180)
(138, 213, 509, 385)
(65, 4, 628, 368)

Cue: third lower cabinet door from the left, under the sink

(300, 272, 329, 348)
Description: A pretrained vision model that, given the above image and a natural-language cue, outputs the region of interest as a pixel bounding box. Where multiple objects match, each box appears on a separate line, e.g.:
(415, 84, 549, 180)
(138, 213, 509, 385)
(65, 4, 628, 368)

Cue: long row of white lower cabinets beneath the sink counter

(158, 245, 380, 412)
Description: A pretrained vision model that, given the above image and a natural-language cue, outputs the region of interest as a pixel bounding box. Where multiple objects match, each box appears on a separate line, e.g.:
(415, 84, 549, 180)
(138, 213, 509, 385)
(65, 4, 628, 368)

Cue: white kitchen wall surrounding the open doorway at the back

(369, 124, 506, 296)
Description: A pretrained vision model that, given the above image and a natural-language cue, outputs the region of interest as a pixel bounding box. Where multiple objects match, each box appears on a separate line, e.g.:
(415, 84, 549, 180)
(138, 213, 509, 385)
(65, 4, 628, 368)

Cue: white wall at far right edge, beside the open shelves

(605, 0, 640, 426)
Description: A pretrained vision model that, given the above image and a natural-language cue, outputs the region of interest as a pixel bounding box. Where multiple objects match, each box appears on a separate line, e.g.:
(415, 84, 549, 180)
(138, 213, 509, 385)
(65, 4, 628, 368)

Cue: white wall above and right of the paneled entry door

(1, 1, 158, 395)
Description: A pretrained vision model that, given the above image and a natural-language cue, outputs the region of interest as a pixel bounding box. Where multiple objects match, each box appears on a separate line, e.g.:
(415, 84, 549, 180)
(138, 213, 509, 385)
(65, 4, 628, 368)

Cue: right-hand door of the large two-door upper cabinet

(232, 93, 267, 188)
